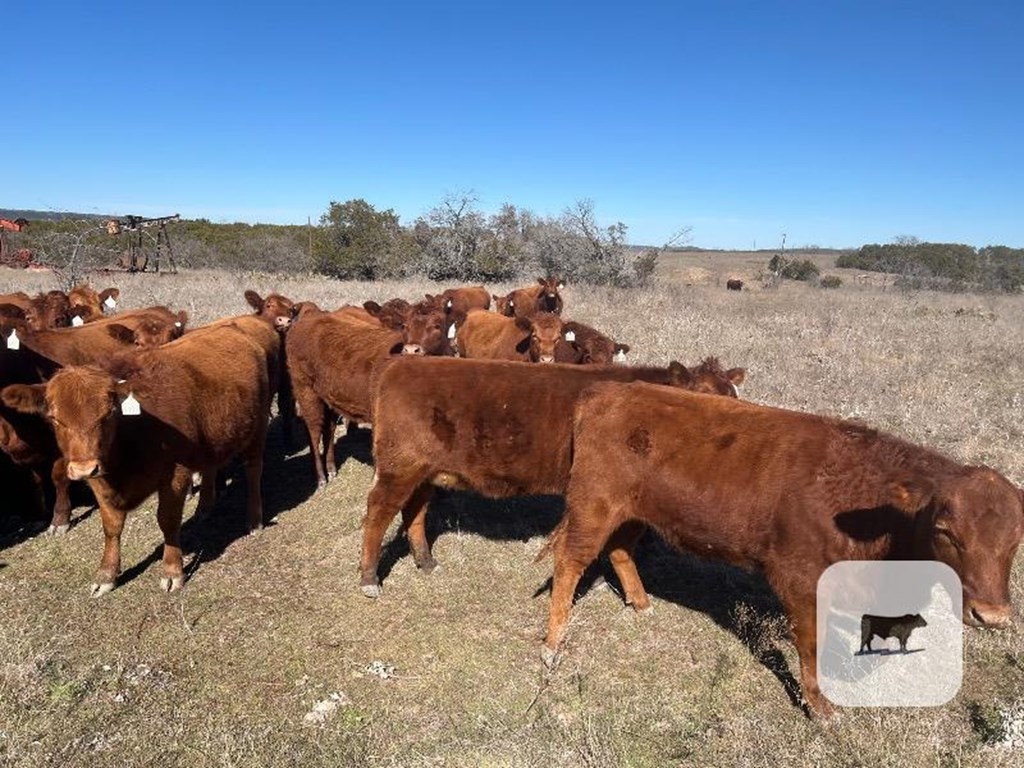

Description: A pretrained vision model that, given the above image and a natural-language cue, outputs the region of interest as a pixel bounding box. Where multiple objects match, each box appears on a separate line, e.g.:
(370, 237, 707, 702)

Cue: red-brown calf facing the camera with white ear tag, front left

(0, 325, 270, 597)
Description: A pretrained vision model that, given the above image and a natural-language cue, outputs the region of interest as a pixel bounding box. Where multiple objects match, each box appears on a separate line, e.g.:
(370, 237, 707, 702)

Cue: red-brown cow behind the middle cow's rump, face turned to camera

(286, 310, 450, 485)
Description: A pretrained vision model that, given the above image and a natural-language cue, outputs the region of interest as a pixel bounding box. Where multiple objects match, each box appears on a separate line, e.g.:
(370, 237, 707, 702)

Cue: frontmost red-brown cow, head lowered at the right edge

(544, 384, 1024, 714)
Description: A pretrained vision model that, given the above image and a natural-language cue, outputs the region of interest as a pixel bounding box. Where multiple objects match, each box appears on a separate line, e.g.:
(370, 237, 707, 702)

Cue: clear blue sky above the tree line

(0, 0, 1024, 248)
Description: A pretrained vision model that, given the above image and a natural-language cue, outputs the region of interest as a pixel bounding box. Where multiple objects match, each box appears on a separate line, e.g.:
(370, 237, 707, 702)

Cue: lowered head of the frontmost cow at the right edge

(909, 467, 1024, 628)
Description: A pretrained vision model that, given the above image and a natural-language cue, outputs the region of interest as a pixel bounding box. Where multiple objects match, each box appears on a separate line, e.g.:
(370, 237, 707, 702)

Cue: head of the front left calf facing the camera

(0, 367, 129, 480)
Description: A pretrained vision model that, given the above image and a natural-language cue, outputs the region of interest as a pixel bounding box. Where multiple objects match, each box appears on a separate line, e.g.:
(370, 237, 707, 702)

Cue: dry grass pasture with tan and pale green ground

(0, 260, 1024, 768)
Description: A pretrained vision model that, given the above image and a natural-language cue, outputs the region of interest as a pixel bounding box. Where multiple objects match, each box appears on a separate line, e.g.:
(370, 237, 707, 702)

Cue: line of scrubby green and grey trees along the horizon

(3, 204, 1024, 293)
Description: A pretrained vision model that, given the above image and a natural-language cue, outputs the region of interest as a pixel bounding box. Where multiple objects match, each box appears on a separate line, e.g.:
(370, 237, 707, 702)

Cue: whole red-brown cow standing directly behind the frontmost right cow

(359, 357, 743, 597)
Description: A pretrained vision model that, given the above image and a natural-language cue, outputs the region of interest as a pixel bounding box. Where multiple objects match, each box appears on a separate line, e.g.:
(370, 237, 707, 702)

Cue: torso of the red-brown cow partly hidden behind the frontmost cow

(374, 357, 696, 498)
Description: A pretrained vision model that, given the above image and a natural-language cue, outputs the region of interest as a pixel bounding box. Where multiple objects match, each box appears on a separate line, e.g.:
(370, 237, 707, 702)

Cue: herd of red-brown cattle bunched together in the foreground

(0, 279, 1024, 714)
